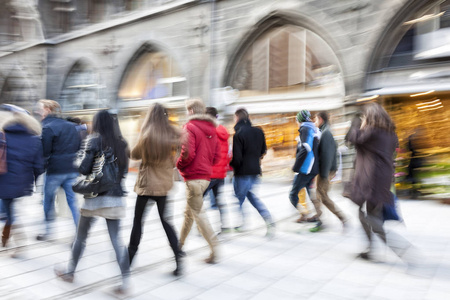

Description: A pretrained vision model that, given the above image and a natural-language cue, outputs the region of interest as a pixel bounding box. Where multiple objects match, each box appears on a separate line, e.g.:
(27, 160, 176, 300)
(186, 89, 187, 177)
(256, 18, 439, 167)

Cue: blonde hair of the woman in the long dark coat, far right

(361, 102, 395, 132)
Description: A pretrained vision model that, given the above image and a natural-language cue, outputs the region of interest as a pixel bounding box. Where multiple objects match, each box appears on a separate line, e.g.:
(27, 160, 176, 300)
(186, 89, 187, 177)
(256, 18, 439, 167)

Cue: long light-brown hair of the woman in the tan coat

(138, 103, 181, 165)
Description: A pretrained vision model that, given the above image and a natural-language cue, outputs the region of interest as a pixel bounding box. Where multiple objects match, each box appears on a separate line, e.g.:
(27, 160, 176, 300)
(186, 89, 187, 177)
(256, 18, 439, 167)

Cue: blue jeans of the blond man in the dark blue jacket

(44, 173, 80, 234)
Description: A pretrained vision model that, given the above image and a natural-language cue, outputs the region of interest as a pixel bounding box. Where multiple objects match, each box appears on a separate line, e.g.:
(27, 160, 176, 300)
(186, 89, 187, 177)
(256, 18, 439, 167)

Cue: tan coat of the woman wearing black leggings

(131, 143, 174, 196)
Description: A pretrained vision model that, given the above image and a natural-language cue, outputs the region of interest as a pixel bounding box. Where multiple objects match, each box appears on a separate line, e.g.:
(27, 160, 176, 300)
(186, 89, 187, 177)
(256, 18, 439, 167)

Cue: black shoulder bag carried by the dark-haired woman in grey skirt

(72, 148, 120, 198)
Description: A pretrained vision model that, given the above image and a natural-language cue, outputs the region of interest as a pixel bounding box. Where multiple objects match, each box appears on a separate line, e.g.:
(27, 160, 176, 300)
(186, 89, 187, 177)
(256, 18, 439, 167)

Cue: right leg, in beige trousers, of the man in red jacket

(186, 180, 218, 262)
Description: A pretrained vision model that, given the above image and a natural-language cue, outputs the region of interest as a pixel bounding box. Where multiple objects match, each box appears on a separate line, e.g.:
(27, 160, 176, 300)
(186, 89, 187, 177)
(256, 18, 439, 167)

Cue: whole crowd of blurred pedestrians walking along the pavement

(0, 99, 418, 293)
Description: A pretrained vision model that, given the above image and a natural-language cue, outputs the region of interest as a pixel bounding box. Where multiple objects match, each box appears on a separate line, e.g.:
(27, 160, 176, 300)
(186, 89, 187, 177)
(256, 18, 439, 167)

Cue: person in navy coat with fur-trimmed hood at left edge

(0, 104, 44, 252)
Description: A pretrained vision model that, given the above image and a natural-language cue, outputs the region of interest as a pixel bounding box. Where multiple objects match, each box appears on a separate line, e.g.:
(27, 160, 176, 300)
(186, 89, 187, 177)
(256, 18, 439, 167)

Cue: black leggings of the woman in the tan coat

(128, 196, 179, 264)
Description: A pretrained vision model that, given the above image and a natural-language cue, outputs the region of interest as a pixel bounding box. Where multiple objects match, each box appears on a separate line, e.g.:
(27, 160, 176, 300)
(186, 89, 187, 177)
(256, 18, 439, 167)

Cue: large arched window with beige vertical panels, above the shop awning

(232, 26, 340, 97)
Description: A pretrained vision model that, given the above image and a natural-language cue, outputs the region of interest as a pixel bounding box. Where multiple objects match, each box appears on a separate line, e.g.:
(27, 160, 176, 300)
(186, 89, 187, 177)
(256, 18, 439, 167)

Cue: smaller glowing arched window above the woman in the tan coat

(119, 52, 187, 101)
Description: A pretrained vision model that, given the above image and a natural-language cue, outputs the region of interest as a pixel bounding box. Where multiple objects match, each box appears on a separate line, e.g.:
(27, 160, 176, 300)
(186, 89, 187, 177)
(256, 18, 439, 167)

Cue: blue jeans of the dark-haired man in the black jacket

(233, 175, 273, 224)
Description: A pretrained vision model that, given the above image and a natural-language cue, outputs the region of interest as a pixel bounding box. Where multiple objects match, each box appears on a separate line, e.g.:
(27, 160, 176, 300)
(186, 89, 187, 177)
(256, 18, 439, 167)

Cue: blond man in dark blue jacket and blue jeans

(37, 100, 80, 240)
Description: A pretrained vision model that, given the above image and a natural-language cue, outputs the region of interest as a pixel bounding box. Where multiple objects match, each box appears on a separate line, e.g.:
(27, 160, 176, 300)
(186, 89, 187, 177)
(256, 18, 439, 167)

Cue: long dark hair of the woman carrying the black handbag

(92, 110, 128, 170)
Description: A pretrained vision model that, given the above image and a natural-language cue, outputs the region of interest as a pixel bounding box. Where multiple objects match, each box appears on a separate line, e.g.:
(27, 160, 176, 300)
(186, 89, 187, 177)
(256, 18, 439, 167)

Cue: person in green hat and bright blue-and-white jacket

(289, 110, 320, 223)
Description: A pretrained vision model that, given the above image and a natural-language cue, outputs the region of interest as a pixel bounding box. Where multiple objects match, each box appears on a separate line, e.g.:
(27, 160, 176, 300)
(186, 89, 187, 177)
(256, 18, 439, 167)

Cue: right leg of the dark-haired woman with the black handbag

(106, 219, 130, 285)
